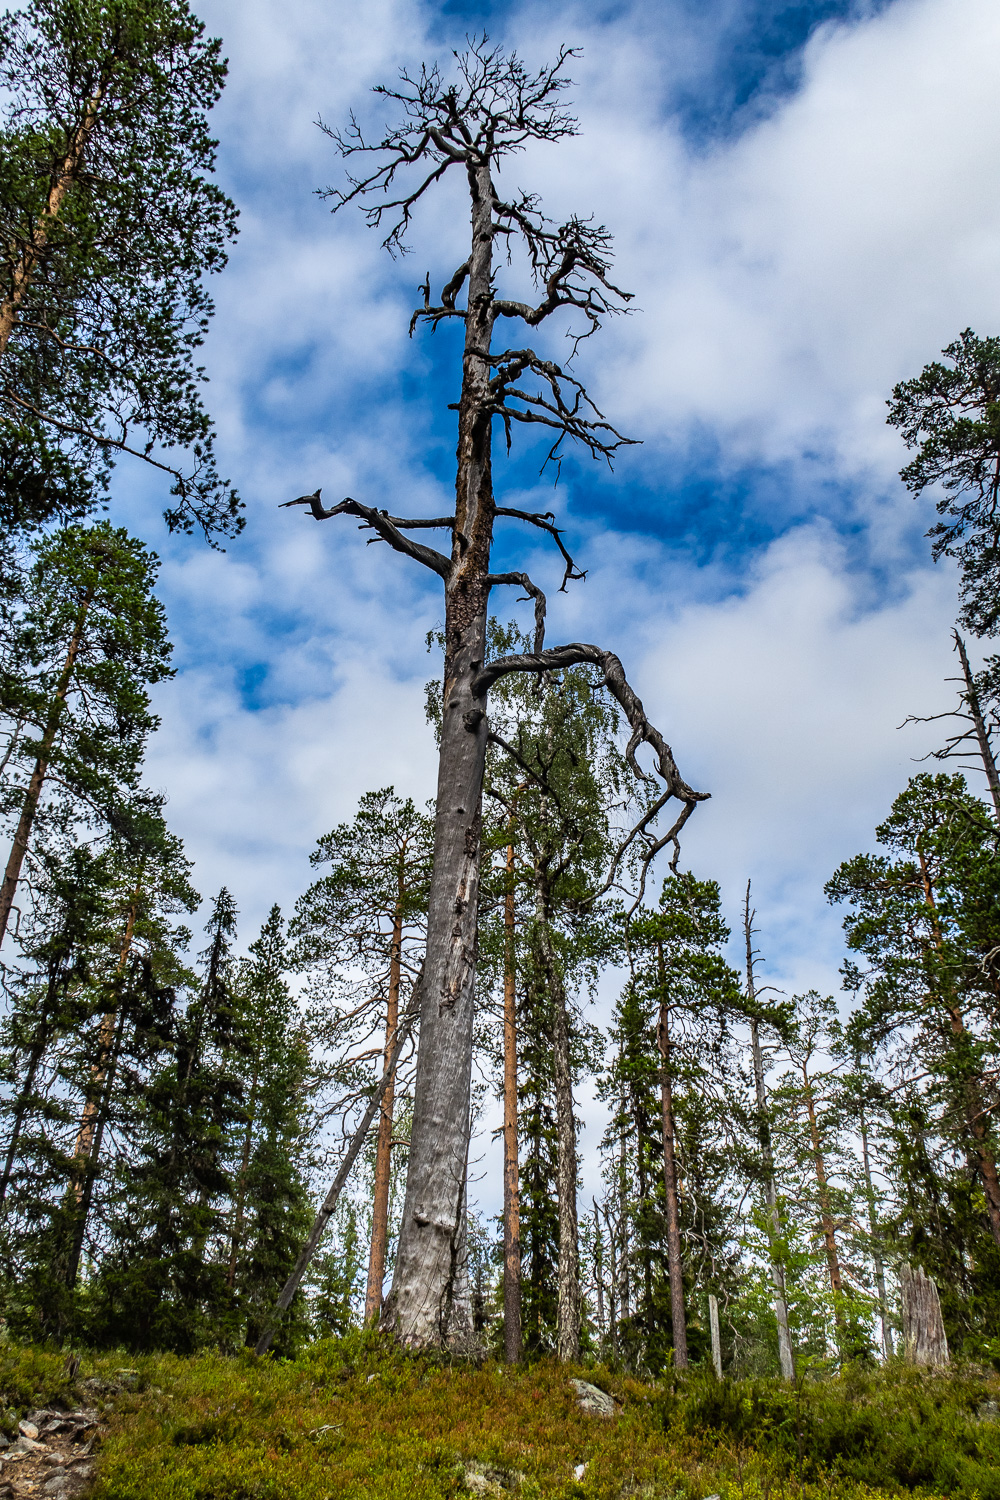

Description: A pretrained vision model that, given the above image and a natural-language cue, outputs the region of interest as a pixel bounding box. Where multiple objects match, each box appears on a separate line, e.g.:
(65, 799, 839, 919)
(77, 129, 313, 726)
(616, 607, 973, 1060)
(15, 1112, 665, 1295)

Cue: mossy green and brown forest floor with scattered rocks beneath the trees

(0, 1335, 1000, 1500)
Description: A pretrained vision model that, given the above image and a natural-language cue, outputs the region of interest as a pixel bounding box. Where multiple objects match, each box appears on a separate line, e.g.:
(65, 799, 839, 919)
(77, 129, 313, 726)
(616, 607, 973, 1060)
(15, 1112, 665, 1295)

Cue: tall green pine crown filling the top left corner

(0, 0, 241, 534)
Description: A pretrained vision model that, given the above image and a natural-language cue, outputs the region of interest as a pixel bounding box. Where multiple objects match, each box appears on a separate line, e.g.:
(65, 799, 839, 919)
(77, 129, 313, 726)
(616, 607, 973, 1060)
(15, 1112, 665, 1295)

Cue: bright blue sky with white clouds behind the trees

(109, 0, 1000, 1194)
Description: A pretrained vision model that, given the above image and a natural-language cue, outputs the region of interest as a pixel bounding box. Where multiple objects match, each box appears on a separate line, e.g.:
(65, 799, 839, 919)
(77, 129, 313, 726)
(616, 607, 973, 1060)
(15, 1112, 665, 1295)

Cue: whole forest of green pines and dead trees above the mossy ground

(0, 0, 1000, 1497)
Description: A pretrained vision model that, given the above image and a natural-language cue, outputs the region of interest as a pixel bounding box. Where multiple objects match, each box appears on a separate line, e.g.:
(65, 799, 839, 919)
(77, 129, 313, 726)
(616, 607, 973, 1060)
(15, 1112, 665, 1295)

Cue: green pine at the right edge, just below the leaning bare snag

(826, 776, 1000, 1247)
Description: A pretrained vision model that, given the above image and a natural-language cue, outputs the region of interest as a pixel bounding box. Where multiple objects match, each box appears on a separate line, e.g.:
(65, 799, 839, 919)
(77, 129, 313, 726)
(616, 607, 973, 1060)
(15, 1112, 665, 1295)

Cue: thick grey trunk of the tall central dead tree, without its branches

(388, 161, 495, 1346)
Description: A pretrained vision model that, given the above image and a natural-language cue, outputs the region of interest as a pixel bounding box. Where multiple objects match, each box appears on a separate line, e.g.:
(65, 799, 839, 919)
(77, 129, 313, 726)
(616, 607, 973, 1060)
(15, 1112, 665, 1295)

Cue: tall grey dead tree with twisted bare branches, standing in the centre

(281, 38, 699, 1346)
